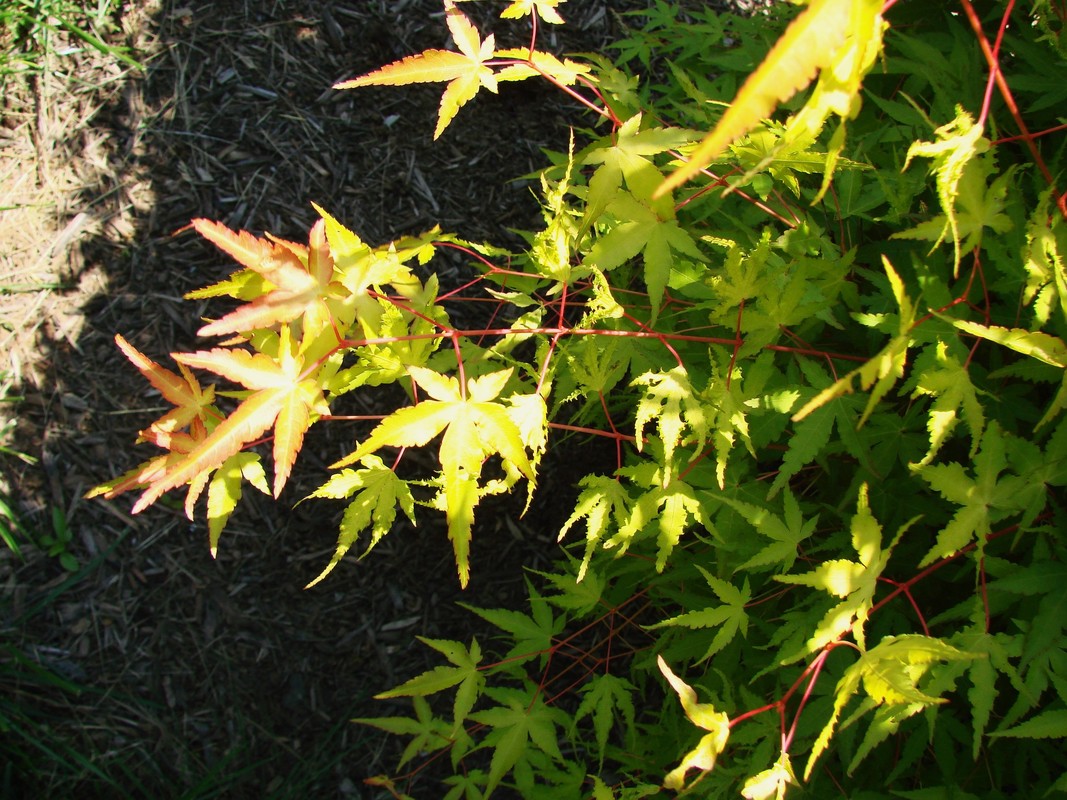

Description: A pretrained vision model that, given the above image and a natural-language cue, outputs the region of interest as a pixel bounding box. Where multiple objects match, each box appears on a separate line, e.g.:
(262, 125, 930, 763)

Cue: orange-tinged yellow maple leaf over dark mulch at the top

(334, 0, 496, 139)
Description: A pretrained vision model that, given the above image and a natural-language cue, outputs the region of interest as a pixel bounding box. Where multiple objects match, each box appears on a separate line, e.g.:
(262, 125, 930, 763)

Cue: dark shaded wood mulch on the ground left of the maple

(0, 0, 647, 798)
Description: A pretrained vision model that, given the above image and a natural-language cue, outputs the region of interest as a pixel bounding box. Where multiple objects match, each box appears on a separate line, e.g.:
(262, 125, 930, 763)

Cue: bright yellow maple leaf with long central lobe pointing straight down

(333, 367, 536, 587)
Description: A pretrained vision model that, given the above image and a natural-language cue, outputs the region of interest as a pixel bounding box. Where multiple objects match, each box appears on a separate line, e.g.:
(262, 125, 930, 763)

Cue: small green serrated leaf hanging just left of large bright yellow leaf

(304, 455, 415, 589)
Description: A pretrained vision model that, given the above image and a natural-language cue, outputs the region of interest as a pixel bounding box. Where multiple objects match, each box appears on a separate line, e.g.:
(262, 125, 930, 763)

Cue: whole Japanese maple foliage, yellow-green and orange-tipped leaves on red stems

(96, 0, 1067, 800)
